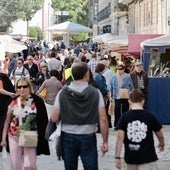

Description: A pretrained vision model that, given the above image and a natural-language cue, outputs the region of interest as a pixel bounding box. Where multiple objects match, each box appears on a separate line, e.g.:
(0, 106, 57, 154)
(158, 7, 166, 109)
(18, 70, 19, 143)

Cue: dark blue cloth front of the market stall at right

(148, 77, 170, 124)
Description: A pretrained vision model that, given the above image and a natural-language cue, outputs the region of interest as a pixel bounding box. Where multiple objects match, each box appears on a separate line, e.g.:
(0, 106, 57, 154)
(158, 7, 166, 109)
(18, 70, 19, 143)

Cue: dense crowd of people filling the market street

(0, 42, 164, 170)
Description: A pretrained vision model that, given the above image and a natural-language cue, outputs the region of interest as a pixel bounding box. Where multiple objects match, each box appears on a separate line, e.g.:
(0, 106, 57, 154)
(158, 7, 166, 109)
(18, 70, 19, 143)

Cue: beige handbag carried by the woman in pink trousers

(18, 130, 38, 147)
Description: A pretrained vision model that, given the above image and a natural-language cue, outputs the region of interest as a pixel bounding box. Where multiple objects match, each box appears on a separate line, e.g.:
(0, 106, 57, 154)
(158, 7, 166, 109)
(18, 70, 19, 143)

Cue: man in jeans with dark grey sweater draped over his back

(51, 62, 108, 170)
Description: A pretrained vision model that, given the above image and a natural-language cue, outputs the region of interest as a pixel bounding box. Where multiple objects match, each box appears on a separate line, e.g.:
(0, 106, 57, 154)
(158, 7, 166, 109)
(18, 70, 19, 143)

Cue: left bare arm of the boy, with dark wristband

(115, 130, 125, 169)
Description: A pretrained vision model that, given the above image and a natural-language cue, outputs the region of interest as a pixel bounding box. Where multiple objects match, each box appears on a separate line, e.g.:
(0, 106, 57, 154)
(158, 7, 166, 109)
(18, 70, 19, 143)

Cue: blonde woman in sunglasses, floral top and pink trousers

(1, 77, 50, 170)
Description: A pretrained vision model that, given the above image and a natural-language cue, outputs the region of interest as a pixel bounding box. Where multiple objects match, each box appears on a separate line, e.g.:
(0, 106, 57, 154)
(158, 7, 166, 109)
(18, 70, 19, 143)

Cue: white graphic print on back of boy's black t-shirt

(127, 120, 148, 150)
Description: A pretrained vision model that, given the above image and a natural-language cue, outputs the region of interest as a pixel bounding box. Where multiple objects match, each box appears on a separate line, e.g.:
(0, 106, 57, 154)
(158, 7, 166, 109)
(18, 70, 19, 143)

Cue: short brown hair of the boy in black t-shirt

(129, 89, 144, 103)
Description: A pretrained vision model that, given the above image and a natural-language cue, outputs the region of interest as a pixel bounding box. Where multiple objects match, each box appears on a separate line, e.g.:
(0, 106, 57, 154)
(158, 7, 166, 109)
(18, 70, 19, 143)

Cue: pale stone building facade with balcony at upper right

(89, 0, 170, 36)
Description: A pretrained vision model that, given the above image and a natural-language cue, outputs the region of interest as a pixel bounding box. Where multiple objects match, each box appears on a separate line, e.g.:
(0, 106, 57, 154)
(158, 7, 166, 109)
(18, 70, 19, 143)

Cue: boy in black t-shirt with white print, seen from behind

(115, 89, 165, 170)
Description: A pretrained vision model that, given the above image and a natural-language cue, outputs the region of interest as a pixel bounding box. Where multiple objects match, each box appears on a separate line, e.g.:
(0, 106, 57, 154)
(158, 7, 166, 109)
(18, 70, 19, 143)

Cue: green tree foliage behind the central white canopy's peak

(52, 0, 89, 26)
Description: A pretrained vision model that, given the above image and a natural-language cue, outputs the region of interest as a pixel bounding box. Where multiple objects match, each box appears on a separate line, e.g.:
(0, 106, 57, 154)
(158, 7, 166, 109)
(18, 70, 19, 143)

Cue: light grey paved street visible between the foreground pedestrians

(38, 125, 170, 170)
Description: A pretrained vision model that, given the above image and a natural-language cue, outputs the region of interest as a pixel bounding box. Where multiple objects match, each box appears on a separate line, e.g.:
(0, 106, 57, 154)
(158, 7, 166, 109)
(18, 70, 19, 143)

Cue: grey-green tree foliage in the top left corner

(0, 0, 43, 32)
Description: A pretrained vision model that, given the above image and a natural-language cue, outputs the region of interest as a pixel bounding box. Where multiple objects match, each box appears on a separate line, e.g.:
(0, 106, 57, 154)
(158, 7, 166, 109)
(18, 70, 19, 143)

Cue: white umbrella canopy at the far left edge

(0, 35, 27, 59)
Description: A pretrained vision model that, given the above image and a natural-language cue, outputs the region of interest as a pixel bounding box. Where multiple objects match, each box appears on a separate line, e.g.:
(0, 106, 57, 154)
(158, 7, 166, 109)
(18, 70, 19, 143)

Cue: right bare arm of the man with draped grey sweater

(99, 107, 109, 155)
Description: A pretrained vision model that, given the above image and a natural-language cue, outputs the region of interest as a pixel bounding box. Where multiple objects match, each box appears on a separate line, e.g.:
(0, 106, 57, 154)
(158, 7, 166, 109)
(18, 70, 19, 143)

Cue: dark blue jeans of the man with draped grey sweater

(63, 132, 98, 170)
